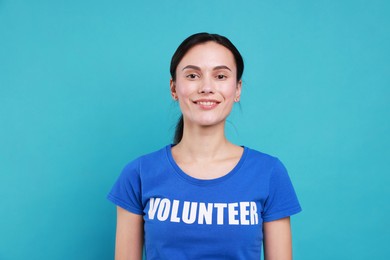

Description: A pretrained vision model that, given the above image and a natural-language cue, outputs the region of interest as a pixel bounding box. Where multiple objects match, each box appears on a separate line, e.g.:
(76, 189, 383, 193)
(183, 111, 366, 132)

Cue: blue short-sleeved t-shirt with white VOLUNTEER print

(108, 145, 301, 260)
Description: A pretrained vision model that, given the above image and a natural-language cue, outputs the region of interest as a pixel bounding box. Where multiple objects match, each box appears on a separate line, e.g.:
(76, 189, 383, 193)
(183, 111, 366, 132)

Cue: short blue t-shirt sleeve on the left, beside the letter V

(107, 160, 143, 215)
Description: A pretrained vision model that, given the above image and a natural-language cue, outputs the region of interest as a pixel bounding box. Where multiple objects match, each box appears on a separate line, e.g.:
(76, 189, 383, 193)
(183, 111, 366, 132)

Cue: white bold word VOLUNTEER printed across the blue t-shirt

(148, 198, 259, 225)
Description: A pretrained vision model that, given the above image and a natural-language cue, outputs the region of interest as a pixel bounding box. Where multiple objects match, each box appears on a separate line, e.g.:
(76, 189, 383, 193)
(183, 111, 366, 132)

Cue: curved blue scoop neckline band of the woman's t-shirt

(165, 144, 249, 186)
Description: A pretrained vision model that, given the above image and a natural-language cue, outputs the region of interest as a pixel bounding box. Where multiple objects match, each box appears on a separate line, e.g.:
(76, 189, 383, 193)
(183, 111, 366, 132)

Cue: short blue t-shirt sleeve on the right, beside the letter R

(263, 160, 302, 222)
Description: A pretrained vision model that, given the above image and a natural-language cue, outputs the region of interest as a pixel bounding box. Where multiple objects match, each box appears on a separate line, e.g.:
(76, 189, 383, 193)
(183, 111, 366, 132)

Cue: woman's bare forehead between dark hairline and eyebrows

(178, 42, 236, 70)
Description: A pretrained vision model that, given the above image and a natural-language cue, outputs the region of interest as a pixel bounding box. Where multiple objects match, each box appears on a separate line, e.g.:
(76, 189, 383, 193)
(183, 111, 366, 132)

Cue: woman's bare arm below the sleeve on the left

(115, 207, 144, 260)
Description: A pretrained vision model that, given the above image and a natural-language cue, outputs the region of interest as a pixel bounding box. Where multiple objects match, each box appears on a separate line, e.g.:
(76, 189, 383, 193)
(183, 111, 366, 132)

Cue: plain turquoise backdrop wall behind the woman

(0, 0, 390, 260)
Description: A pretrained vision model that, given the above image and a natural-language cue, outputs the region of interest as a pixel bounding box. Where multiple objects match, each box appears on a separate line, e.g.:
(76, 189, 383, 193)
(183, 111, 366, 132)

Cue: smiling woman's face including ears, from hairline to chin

(171, 42, 241, 127)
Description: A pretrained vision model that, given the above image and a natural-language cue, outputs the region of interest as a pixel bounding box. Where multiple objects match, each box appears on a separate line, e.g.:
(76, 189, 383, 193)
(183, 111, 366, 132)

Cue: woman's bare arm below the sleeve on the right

(264, 217, 292, 260)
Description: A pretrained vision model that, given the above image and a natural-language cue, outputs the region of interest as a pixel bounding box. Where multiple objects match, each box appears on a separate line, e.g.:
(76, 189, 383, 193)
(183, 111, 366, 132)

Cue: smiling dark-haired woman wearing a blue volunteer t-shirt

(108, 33, 301, 260)
